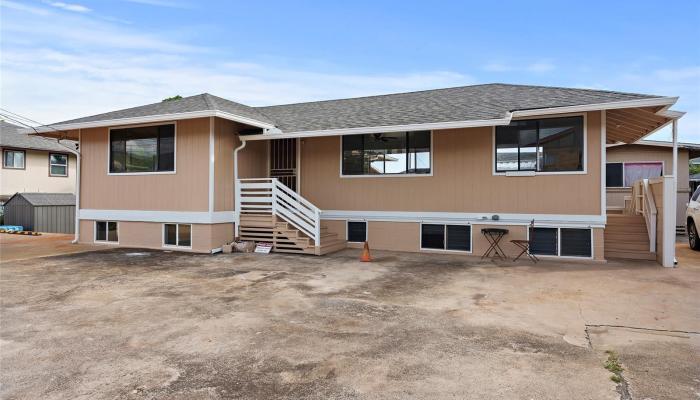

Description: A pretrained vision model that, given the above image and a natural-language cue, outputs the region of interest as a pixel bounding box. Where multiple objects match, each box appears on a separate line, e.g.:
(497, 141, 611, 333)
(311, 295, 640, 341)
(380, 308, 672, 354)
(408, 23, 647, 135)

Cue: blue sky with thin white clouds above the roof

(0, 0, 700, 142)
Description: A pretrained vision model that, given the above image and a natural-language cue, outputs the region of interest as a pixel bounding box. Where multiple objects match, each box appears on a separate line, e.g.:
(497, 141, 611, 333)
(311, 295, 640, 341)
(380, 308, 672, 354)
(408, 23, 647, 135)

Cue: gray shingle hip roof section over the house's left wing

(61, 93, 273, 124)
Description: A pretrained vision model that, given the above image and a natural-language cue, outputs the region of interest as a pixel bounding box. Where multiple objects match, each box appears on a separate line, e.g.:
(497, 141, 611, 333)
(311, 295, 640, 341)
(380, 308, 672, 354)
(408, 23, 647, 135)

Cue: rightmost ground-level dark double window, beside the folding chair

(530, 227, 593, 257)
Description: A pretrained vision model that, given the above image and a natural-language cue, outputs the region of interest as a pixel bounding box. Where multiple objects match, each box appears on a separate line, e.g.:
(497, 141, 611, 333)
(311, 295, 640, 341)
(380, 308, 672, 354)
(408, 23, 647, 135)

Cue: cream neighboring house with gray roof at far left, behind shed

(0, 121, 77, 203)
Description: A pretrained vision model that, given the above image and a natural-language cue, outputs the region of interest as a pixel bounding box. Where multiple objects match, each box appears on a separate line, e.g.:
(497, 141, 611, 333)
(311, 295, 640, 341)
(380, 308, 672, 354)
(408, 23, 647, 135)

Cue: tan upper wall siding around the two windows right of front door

(301, 112, 601, 215)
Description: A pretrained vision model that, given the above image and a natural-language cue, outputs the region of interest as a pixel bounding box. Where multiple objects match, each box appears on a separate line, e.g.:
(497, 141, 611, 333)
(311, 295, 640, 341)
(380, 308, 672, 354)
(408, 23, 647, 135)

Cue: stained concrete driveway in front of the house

(0, 249, 700, 400)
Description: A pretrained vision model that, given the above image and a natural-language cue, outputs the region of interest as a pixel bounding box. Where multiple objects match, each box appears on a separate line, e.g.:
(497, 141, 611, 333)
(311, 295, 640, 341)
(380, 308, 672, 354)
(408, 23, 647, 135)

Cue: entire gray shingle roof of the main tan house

(47, 83, 661, 132)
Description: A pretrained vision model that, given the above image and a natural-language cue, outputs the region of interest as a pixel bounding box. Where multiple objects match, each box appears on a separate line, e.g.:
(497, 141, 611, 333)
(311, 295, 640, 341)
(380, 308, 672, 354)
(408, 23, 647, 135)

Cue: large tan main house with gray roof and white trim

(31, 84, 683, 266)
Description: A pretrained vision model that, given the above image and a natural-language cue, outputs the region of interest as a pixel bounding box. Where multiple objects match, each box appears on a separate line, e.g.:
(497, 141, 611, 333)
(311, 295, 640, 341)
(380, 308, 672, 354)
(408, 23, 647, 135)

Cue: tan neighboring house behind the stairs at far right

(606, 140, 700, 231)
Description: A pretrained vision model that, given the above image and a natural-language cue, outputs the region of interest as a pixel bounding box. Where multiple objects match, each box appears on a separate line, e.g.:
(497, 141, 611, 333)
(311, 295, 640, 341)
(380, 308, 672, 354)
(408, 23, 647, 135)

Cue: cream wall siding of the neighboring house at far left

(0, 150, 77, 196)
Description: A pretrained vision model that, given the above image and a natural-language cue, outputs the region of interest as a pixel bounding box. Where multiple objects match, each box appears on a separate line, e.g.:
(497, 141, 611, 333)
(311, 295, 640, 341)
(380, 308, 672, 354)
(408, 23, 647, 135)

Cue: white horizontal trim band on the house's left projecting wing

(78, 209, 235, 224)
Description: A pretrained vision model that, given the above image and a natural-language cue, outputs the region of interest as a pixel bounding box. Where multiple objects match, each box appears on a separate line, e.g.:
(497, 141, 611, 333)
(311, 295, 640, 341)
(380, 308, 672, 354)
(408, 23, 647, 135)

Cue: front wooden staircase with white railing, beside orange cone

(236, 178, 347, 256)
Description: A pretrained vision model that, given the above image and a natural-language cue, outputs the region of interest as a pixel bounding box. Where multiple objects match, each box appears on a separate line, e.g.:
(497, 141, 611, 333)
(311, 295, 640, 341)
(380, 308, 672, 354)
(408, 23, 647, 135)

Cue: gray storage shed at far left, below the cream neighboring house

(5, 193, 75, 233)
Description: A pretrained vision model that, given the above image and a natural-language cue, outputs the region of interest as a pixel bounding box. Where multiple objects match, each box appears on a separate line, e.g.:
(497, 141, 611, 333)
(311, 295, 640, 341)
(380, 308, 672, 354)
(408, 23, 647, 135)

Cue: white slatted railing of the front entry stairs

(236, 178, 321, 246)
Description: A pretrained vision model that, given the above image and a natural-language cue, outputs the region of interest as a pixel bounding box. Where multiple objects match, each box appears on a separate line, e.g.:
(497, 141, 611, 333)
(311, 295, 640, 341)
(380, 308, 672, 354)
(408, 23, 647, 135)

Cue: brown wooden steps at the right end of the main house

(605, 214, 656, 260)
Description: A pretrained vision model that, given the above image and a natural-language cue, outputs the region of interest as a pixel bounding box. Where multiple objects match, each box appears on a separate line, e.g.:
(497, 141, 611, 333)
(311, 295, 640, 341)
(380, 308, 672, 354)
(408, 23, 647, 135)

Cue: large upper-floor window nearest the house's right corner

(495, 117, 584, 172)
